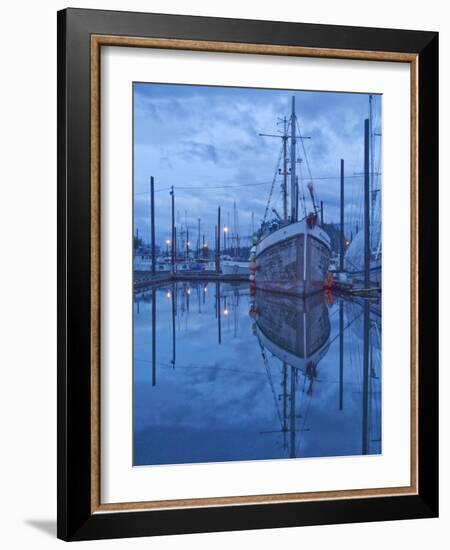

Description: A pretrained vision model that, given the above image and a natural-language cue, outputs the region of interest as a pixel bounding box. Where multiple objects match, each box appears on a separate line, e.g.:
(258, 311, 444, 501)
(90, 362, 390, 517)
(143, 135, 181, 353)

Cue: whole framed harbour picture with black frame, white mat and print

(58, 9, 438, 540)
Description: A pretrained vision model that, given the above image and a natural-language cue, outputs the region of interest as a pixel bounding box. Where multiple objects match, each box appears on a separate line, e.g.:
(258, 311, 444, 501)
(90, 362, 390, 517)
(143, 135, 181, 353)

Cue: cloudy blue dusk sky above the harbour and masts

(134, 83, 381, 249)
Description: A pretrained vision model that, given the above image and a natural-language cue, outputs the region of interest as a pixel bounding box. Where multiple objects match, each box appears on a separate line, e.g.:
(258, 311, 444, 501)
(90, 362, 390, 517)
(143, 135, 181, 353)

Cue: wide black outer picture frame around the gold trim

(57, 9, 438, 540)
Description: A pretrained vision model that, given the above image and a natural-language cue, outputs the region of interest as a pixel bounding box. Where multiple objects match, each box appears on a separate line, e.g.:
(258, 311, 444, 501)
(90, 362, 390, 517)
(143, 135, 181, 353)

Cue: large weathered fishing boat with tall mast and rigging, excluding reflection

(255, 97, 331, 296)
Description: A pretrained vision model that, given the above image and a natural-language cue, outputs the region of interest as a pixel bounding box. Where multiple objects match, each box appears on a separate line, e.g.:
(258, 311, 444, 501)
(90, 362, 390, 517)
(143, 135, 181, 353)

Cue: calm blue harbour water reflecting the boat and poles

(134, 282, 381, 465)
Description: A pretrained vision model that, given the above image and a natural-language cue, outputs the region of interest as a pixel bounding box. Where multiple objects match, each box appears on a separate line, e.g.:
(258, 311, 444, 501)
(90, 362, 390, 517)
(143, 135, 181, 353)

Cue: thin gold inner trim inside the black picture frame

(90, 35, 419, 514)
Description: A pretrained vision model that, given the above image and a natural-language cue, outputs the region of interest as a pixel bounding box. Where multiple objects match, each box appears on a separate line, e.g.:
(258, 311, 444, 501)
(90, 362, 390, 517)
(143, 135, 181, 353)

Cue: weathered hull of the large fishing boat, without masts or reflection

(255, 221, 331, 296)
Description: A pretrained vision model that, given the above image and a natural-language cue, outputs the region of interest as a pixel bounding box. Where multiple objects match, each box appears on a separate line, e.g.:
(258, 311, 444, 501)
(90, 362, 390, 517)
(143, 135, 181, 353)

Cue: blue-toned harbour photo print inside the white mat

(129, 82, 382, 466)
